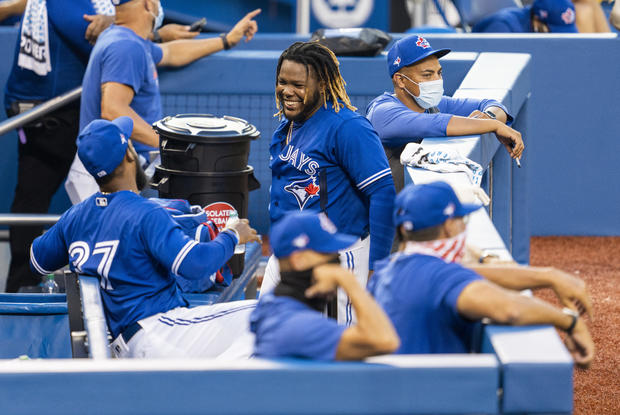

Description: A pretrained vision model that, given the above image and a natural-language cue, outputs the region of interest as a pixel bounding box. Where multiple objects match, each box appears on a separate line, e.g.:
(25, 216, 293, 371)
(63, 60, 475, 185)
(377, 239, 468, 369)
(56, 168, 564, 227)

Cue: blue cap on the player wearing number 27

(77, 116, 133, 178)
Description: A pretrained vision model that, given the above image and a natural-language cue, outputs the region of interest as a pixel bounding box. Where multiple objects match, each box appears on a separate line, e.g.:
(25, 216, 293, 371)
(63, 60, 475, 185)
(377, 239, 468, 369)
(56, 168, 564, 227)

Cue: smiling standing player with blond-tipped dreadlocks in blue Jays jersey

(261, 42, 395, 325)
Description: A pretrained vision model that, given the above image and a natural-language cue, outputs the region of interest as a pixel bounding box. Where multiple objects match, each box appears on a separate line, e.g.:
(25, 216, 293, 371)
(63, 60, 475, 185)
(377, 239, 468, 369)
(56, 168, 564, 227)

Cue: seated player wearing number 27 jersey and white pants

(30, 117, 258, 358)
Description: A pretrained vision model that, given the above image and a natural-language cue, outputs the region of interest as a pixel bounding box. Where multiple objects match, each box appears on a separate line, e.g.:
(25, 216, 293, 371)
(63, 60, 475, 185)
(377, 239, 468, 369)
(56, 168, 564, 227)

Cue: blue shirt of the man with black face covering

(250, 293, 346, 361)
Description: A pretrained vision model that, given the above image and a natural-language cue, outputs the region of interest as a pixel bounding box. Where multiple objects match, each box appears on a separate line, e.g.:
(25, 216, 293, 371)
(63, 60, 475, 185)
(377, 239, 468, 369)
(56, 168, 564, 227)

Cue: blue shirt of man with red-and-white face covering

(368, 253, 482, 354)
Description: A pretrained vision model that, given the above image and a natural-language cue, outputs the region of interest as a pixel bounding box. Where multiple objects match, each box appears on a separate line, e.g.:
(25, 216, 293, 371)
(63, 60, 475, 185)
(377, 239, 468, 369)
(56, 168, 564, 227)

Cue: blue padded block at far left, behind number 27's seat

(0, 294, 71, 360)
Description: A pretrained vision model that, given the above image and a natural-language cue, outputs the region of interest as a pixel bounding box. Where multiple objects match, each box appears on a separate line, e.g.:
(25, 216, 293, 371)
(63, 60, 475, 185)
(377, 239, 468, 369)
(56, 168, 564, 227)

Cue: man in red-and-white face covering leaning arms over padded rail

(368, 182, 594, 367)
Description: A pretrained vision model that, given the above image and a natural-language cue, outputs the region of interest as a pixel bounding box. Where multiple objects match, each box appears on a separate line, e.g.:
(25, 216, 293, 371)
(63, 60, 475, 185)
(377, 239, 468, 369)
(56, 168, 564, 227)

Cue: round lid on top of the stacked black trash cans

(154, 114, 260, 139)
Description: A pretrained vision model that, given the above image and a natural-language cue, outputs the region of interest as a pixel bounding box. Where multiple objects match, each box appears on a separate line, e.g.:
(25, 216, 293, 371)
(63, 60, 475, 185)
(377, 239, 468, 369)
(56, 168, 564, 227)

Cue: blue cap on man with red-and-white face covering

(394, 182, 482, 231)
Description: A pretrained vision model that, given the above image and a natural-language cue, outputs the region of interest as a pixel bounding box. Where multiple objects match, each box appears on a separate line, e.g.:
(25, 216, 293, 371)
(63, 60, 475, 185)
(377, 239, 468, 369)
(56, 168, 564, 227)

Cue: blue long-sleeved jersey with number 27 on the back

(30, 191, 237, 337)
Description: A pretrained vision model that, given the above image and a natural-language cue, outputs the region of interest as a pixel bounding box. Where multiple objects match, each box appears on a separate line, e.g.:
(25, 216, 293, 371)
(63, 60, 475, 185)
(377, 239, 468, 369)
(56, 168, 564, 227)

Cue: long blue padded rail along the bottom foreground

(0, 354, 499, 415)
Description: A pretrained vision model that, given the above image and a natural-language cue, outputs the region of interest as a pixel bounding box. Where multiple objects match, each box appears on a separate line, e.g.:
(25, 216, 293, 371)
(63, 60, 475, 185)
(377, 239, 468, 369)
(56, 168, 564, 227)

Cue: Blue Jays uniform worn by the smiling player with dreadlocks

(261, 102, 394, 324)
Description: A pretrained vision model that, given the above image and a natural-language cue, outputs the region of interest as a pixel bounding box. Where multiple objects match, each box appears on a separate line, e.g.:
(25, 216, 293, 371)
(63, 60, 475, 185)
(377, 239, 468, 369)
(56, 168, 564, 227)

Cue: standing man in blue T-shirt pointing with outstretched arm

(65, 0, 260, 203)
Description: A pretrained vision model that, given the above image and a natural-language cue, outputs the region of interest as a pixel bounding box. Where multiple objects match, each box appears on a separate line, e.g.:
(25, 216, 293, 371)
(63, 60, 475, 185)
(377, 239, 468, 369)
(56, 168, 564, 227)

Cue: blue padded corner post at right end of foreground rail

(482, 326, 573, 414)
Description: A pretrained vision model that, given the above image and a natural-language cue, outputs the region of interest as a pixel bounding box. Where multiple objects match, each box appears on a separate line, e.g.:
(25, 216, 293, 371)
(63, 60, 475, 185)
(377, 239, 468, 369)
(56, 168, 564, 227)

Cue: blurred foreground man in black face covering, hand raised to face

(250, 212, 399, 361)
